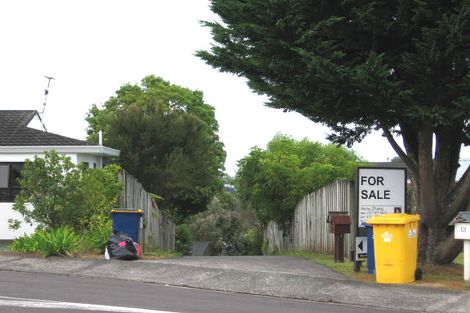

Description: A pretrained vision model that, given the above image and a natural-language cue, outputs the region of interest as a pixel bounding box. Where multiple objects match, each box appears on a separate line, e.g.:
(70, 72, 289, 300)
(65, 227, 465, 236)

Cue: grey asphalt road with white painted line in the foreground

(0, 271, 410, 313)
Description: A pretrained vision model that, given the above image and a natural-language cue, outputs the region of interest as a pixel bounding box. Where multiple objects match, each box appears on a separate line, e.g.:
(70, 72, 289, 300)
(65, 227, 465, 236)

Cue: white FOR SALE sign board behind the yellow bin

(357, 167, 406, 227)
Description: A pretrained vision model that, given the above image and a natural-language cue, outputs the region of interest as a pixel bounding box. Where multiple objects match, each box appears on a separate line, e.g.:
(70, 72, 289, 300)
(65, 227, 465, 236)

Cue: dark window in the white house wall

(0, 162, 24, 202)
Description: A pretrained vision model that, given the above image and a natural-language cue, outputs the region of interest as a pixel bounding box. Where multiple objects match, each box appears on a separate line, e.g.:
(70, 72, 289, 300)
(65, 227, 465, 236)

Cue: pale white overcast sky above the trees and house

(0, 0, 470, 175)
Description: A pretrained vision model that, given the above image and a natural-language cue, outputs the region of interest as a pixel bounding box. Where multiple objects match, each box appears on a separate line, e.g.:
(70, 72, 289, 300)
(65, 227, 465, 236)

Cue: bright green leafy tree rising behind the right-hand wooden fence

(235, 135, 359, 225)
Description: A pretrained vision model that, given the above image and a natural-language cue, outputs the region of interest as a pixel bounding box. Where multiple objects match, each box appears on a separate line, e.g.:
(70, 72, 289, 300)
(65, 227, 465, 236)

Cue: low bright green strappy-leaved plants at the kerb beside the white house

(9, 226, 82, 257)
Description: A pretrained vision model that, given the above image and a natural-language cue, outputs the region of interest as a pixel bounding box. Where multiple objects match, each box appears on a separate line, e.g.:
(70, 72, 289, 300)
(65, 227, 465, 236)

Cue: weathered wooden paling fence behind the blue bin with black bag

(119, 171, 175, 251)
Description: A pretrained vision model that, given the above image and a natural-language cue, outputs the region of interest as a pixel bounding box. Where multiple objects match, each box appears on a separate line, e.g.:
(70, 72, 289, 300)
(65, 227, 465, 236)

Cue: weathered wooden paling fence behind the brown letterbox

(264, 180, 355, 256)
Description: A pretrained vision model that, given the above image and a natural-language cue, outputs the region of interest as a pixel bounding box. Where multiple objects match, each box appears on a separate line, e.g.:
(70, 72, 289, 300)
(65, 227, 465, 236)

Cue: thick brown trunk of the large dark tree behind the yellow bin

(386, 123, 470, 264)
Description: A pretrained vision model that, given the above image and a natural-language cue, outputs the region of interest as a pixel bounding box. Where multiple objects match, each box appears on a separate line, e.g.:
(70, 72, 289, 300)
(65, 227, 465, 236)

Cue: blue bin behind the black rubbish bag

(111, 209, 144, 242)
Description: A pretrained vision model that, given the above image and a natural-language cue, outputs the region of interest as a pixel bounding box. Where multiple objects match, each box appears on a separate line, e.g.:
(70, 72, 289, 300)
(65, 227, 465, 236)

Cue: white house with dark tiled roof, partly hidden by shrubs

(0, 110, 120, 241)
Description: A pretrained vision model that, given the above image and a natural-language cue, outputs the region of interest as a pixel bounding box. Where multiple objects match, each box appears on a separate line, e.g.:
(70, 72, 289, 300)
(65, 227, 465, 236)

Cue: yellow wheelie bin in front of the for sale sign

(367, 213, 420, 284)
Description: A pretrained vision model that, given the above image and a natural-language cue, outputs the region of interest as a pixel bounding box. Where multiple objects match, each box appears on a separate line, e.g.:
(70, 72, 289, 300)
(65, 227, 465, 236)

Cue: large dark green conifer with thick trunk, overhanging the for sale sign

(198, 0, 470, 263)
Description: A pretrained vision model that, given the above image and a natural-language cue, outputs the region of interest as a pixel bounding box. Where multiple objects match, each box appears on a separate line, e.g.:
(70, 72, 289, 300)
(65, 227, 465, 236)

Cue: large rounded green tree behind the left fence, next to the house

(87, 76, 225, 220)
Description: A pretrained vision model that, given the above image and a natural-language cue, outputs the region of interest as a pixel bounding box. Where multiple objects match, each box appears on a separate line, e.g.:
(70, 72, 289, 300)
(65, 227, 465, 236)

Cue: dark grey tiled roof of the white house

(0, 110, 91, 146)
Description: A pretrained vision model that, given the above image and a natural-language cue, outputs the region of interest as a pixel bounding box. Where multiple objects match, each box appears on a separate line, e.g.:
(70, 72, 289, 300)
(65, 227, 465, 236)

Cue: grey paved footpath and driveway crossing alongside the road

(0, 253, 470, 313)
